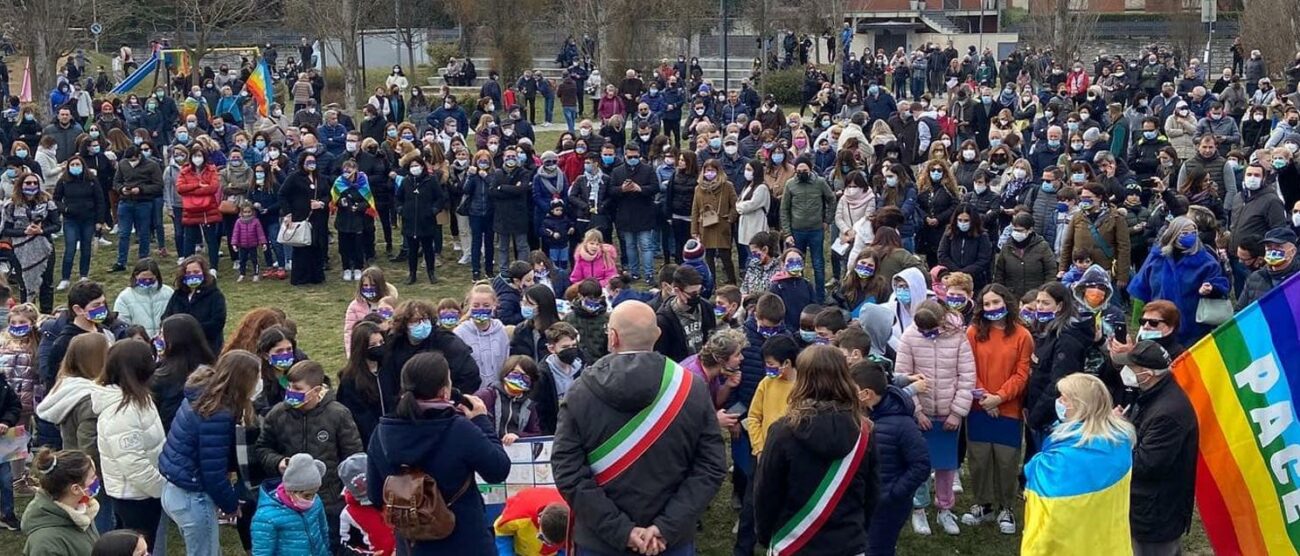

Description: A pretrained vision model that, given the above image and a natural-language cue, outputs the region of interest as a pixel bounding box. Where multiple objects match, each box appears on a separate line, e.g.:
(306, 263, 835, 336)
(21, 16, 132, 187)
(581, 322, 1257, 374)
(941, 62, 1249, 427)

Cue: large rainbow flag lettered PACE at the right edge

(1174, 271, 1300, 555)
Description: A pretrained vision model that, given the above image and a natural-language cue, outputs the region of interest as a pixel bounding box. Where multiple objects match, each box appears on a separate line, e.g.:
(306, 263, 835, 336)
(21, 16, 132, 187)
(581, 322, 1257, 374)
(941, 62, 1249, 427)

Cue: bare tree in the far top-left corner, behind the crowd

(5, 0, 130, 110)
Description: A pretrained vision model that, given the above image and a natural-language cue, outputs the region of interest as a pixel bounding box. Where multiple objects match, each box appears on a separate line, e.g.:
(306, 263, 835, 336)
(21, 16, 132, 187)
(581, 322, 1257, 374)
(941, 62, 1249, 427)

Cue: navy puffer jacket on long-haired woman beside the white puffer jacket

(159, 388, 239, 513)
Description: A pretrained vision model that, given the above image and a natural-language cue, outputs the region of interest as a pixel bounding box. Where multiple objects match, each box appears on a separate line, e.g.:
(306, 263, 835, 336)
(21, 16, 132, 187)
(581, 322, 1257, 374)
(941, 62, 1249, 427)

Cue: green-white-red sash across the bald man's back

(586, 359, 692, 486)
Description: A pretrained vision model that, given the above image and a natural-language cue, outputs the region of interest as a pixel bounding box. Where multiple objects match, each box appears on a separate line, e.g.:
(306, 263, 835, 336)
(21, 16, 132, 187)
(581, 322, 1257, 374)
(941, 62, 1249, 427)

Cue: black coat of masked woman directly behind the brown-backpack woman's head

(380, 326, 482, 411)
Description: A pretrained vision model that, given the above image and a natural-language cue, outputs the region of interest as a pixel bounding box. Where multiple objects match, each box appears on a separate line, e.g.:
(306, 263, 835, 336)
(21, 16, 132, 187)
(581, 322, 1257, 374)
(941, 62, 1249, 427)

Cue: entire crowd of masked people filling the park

(0, 30, 1300, 555)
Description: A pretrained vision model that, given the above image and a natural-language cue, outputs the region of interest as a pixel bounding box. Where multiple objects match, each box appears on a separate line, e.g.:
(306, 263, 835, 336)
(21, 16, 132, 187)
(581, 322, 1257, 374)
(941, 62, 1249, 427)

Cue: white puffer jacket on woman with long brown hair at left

(91, 386, 166, 500)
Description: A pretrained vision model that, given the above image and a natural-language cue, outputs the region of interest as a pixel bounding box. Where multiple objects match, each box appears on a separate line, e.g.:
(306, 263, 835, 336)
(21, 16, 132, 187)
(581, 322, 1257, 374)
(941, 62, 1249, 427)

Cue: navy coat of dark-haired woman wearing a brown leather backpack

(367, 408, 510, 556)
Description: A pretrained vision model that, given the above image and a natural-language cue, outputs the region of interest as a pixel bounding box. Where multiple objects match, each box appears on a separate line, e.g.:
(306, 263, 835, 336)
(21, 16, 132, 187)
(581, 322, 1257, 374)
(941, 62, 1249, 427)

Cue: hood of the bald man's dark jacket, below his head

(582, 352, 667, 413)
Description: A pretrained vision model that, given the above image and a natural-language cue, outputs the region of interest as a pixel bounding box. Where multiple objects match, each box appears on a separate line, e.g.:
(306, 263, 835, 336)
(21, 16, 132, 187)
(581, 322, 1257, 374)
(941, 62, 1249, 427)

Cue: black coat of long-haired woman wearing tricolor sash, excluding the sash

(754, 411, 880, 555)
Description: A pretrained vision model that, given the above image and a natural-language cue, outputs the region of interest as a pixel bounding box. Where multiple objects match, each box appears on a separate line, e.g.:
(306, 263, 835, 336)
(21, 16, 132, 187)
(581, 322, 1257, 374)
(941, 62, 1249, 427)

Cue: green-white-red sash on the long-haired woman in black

(767, 421, 871, 556)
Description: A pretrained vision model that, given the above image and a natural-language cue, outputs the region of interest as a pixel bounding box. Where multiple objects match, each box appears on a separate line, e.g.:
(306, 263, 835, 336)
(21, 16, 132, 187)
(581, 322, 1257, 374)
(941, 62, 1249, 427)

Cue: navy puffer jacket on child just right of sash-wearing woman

(871, 386, 930, 505)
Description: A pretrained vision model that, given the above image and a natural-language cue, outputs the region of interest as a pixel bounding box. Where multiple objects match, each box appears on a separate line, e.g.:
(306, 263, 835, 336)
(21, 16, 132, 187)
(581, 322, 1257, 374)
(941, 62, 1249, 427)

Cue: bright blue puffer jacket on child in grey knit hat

(252, 481, 330, 556)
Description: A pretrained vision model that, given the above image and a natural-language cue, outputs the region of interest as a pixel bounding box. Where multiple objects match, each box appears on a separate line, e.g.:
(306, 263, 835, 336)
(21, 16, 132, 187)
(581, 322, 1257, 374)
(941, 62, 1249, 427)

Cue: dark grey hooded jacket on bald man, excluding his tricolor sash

(551, 352, 727, 555)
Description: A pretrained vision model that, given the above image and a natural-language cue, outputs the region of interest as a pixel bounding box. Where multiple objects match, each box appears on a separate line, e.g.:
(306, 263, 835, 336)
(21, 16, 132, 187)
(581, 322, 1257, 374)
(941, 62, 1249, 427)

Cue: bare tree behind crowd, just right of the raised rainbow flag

(286, 0, 377, 108)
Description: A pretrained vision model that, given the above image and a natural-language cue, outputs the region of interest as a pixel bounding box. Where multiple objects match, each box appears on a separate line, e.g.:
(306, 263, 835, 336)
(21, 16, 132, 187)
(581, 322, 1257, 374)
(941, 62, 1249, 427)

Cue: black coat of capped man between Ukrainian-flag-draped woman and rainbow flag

(1128, 375, 1199, 543)
